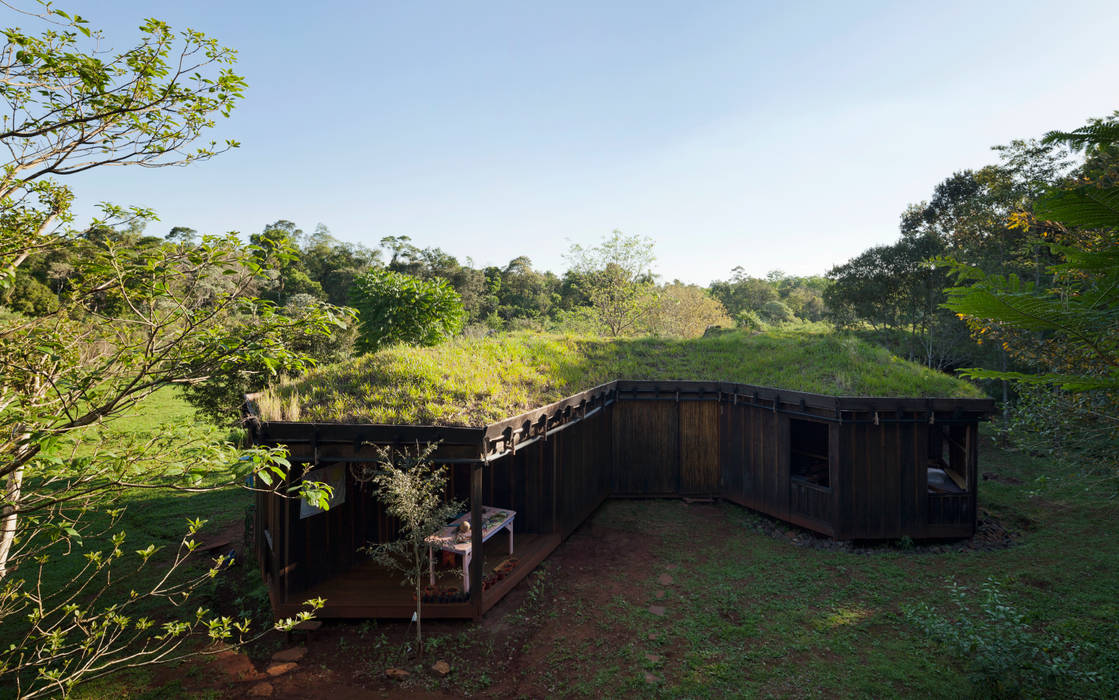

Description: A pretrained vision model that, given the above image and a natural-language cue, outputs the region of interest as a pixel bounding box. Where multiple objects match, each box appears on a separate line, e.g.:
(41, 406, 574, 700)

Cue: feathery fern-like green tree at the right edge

(946, 120, 1119, 476)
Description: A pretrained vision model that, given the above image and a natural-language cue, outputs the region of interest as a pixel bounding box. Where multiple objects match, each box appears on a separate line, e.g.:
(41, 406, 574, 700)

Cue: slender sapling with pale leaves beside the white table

(366, 444, 461, 654)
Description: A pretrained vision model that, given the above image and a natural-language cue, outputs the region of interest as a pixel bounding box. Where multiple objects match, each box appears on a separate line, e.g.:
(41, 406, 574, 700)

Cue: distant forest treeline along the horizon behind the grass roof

(2, 120, 1116, 400)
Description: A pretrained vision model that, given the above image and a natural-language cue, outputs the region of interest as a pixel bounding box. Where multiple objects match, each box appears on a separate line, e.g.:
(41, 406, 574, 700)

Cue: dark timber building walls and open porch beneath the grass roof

(246, 380, 994, 618)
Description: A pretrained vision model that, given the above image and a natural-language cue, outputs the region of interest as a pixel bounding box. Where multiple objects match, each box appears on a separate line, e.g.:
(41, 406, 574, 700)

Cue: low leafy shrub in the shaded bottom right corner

(905, 578, 1099, 698)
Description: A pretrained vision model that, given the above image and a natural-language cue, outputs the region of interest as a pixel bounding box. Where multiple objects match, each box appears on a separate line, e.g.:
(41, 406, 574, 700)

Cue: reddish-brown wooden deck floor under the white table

(272, 533, 561, 619)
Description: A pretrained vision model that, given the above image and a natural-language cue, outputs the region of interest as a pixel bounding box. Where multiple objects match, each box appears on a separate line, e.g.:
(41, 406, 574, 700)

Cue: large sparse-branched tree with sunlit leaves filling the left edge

(0, 4, 336, 697)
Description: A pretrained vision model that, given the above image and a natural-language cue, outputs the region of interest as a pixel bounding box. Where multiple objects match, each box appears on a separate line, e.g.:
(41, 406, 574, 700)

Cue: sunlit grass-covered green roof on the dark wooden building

(260, 331, 982, 426)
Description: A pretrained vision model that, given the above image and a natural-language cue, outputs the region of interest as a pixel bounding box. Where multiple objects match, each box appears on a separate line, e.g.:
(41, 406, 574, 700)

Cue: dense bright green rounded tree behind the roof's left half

(350, 268, 466, 352)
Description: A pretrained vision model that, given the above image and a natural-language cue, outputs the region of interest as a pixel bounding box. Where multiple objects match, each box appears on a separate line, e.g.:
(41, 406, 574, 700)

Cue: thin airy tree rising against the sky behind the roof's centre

(566, 229, 657, 337)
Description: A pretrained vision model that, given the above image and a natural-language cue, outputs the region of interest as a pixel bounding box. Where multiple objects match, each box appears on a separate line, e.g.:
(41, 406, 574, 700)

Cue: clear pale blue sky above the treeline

(59, 0, 1119, 283)
